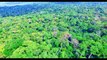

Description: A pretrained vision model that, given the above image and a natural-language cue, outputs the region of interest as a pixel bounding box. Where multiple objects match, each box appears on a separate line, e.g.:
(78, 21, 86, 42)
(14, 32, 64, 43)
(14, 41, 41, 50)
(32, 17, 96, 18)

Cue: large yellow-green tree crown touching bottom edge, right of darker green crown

(10, 41, 38, 58)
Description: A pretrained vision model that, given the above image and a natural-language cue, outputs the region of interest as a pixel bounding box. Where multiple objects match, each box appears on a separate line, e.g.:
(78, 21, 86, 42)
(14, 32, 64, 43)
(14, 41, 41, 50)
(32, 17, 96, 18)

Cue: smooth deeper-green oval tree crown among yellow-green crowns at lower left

(3, 39, 23, 56)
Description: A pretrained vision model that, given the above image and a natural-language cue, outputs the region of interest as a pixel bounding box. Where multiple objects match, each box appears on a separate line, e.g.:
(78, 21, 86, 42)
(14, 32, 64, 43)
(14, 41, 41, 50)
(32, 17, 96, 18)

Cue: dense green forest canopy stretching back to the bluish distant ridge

(0, 2, 107, 58)
